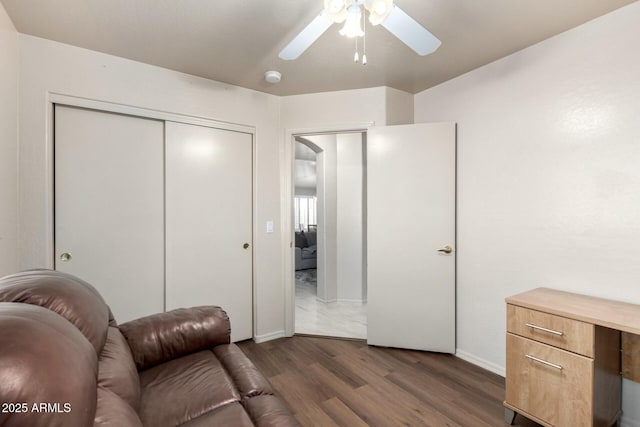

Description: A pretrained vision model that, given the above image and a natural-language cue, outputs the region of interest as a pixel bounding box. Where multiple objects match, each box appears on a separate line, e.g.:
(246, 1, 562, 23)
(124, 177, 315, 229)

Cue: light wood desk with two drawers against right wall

(504, 288, 640, 427)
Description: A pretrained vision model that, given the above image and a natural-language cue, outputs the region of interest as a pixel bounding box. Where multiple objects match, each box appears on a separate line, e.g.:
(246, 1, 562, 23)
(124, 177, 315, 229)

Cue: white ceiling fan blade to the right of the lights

(382, 5, 442, 56)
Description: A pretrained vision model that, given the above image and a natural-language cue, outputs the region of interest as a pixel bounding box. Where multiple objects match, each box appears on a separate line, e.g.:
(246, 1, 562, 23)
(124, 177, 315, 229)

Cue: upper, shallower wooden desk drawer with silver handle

(507, 304, 595, 357)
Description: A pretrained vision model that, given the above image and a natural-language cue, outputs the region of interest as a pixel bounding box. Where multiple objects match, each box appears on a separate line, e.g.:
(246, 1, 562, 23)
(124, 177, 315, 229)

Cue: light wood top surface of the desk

(506, 288, 640, 335)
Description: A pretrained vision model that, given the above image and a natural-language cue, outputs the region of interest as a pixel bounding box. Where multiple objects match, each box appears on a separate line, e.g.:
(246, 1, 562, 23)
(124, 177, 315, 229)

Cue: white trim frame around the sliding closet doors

(45, 92, 258, 338)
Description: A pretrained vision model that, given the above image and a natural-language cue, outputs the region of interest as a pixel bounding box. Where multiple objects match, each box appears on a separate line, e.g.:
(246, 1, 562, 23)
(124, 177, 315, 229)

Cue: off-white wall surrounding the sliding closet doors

(19, 34, 284, 339)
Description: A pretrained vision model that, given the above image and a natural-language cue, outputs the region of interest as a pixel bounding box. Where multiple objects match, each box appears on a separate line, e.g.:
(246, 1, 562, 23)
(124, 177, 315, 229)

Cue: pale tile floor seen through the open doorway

(296, 270, 367, 339)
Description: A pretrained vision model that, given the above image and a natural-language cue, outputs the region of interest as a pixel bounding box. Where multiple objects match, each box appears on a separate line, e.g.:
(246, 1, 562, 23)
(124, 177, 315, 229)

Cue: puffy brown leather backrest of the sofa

(0, 270, 141, 427)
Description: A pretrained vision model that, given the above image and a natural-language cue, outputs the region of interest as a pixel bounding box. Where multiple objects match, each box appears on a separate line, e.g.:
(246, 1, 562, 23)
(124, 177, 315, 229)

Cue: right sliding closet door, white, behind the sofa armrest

(166, 122, 253, 341)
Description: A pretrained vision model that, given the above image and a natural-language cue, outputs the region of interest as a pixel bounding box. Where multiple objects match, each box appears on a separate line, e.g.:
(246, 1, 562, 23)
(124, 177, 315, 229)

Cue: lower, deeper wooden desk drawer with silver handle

(506, 334, 593, 427)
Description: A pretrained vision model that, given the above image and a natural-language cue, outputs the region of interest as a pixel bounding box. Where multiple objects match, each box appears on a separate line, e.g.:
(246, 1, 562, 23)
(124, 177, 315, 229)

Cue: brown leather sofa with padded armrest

(0, 270, 298, 427)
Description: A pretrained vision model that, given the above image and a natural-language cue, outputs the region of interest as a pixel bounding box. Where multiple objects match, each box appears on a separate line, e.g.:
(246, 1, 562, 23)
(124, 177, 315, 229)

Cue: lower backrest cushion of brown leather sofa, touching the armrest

(98, 326, 140, 411)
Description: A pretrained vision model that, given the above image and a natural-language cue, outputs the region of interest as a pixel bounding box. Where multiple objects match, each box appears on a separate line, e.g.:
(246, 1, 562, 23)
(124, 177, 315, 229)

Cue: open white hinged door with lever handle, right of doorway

(367, 123, 456, 353)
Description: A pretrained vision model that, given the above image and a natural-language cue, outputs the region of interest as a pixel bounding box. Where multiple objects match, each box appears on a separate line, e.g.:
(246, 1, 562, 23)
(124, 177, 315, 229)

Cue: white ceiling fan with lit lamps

(278, 0, 442, 60)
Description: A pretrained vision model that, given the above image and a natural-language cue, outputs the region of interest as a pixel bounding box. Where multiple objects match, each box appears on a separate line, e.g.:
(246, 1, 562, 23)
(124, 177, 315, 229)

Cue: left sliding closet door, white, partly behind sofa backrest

(54, 105, 164, 322)
